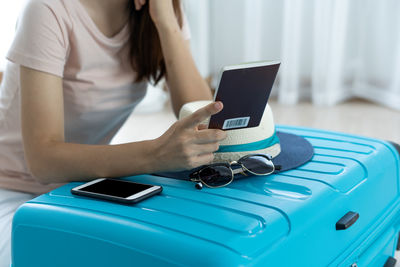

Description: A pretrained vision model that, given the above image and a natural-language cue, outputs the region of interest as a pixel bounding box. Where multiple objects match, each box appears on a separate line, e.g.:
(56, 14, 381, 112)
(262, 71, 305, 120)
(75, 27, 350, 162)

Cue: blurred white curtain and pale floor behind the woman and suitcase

(0, 0, 400, 147)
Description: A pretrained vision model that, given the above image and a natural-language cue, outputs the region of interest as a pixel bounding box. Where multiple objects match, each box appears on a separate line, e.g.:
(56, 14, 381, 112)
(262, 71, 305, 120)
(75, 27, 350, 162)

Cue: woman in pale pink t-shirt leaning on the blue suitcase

(0, 0, 226, 267)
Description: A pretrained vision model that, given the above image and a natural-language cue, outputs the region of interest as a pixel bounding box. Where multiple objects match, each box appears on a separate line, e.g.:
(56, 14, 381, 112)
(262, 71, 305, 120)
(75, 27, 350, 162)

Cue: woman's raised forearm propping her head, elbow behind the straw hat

(135, 0, 212, 115)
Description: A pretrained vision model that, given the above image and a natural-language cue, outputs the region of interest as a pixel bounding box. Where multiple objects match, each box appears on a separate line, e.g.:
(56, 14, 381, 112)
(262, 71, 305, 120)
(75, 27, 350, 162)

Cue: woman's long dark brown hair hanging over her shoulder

(128, 0, 183, 84)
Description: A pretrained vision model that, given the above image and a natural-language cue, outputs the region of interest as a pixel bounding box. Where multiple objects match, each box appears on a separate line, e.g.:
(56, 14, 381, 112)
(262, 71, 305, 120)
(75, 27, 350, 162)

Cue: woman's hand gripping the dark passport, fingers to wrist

(154, 101, 226, 171)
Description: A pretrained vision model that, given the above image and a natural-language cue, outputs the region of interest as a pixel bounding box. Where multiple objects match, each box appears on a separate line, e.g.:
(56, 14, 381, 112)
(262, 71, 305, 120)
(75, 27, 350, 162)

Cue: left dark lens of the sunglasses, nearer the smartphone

(199, 165, 233, 187)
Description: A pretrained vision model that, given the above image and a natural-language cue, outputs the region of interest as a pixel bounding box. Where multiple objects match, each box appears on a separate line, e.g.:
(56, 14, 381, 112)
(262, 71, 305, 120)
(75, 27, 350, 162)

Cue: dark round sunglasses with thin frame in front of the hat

(189, 154, 281, 189)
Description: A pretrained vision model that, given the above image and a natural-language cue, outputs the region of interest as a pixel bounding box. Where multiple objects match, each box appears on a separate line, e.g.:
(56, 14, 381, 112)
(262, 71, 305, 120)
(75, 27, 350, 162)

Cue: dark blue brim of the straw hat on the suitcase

(154, 131, 314, 180)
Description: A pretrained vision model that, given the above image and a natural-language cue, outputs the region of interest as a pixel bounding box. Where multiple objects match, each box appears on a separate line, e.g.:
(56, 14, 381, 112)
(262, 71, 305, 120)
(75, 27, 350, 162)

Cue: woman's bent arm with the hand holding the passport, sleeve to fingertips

(20, 67, 226, 183)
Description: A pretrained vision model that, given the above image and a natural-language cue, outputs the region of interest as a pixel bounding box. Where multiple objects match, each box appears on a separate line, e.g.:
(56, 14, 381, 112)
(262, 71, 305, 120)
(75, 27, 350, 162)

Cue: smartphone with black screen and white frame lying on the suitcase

(71, 178, 162, 204)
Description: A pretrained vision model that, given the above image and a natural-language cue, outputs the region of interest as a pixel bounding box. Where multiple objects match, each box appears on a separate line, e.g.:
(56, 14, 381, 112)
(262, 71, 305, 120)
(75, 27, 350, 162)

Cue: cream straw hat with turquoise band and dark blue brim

(179, 101, 314, 171)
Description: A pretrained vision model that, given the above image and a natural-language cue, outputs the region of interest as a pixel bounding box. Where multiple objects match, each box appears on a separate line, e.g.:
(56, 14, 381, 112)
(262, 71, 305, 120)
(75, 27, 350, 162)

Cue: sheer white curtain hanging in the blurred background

(185, 0, 400, 110)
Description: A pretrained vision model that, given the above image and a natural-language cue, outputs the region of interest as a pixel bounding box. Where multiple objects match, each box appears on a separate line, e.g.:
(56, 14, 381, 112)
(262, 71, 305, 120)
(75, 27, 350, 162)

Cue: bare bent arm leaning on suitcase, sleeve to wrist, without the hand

(21, 67, 154, 183)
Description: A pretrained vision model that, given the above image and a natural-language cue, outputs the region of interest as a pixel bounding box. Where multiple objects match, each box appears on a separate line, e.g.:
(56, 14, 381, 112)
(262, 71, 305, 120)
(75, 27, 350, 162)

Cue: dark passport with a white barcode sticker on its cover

(208, 61, 280, 130)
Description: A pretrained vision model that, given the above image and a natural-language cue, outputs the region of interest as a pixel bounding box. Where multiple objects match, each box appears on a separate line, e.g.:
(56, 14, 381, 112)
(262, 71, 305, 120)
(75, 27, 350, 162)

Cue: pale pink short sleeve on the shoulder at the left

(7, 0, 68, 77)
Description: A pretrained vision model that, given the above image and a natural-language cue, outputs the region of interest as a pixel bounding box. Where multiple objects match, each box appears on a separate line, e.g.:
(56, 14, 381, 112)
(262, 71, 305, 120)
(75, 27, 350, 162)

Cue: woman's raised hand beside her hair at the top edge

(134, 0, 177, 27)
